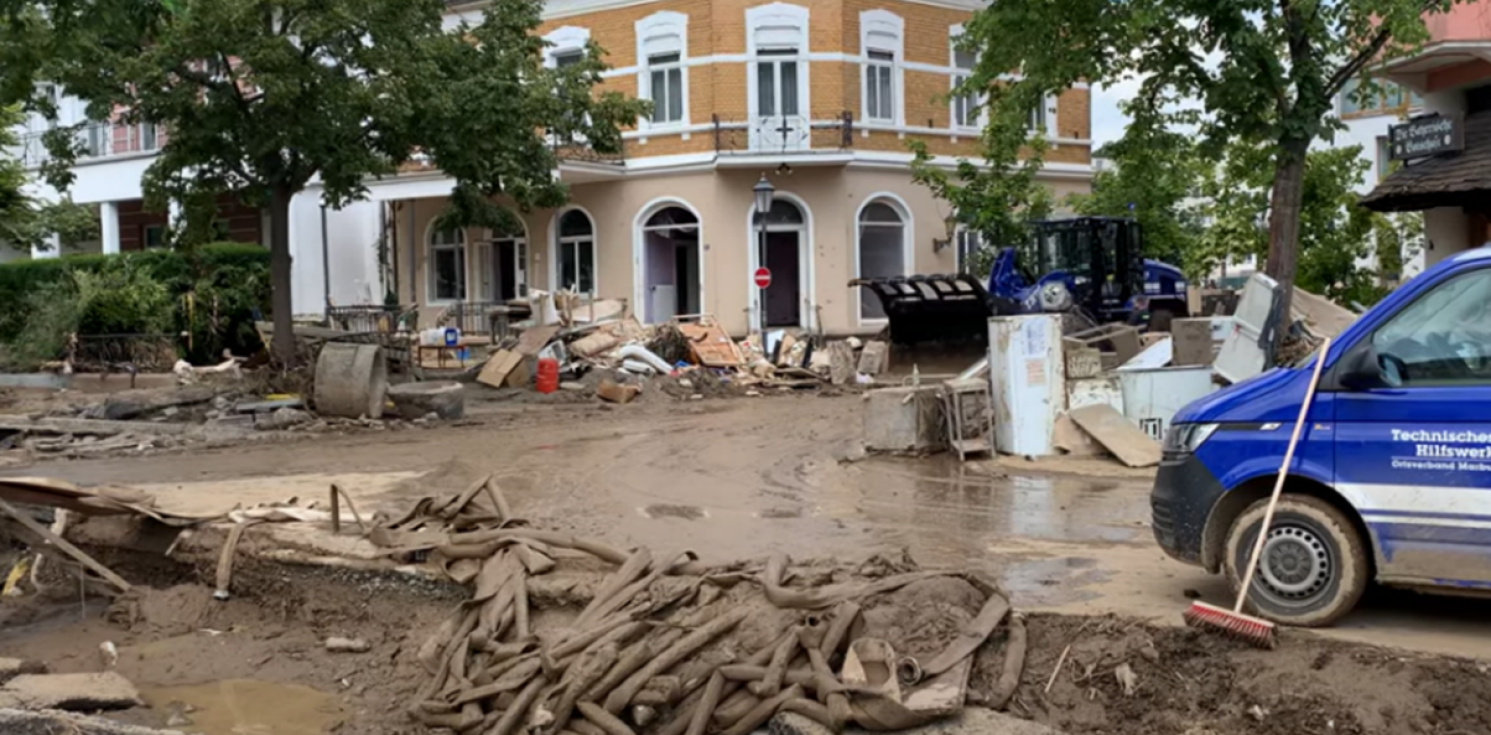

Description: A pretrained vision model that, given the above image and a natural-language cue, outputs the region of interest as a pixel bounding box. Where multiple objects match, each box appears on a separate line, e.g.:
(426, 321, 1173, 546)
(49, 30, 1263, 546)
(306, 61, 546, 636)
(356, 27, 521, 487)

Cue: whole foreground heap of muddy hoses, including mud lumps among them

(368, 479, 1024, 735)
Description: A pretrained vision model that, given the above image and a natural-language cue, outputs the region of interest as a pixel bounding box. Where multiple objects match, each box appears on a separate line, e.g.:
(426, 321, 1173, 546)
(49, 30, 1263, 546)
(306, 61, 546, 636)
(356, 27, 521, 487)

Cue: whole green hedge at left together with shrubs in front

(0, 243, 270, 367)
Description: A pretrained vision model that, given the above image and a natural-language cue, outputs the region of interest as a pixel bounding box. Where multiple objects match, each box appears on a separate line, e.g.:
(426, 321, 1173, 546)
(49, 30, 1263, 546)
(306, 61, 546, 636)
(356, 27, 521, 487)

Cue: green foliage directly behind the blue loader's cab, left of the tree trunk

(1068, 115, 1205, 272)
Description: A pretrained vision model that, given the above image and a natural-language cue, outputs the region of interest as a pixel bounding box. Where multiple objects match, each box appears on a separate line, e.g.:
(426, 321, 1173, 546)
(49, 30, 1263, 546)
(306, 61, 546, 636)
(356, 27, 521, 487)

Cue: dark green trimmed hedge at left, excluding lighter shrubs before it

(0, 243, 270, 362)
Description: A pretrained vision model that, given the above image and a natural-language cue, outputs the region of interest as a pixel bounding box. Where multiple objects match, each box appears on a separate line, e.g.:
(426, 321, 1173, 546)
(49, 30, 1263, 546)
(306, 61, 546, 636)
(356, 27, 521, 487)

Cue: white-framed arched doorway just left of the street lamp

(637, 204, 702, 324)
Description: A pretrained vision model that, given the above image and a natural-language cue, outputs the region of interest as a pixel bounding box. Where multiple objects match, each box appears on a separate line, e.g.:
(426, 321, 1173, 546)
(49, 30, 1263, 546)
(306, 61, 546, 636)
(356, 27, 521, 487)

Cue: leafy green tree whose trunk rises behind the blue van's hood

(965, 0, 1460, 326)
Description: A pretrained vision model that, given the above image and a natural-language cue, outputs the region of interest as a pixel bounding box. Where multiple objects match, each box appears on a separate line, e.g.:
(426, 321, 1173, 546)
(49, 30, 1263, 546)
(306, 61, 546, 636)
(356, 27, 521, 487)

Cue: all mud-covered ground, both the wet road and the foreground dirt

(0, 392, 1491, 735)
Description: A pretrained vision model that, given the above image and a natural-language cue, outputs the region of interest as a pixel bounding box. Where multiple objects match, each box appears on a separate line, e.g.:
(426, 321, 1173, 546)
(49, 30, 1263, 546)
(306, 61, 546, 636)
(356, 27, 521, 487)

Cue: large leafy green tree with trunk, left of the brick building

(0, 0, 644, 362)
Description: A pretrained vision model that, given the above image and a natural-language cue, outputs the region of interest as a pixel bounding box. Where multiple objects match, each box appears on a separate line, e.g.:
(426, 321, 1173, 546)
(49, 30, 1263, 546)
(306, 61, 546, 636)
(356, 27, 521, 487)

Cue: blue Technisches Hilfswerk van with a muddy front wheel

(1151, 247, 1491, 626)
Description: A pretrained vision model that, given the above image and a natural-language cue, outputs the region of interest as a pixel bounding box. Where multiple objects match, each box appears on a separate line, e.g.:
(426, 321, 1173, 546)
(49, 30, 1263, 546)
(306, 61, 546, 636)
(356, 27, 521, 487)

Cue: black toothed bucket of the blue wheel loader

(848, 274, 1014, 344)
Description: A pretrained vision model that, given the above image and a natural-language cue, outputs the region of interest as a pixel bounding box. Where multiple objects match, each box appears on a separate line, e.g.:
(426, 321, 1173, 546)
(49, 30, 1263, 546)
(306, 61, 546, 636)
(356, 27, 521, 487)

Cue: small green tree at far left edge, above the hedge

(0, 104, 97, 250)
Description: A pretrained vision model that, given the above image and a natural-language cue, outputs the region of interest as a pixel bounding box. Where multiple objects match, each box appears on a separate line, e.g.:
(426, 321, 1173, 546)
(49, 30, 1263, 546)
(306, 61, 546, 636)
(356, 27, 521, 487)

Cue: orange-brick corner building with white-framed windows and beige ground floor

(373, 0, 1091, 334)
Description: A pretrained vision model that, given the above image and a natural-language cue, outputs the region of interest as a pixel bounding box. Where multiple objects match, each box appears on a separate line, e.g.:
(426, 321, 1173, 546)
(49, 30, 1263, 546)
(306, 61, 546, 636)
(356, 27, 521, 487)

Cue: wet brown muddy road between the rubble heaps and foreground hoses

(3, 394, 1491, 659)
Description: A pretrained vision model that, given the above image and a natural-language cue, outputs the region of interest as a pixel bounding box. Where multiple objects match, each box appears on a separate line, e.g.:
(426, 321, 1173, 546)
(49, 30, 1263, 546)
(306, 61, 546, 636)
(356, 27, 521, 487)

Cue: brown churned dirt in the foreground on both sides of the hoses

(0, 552, 1491, 735)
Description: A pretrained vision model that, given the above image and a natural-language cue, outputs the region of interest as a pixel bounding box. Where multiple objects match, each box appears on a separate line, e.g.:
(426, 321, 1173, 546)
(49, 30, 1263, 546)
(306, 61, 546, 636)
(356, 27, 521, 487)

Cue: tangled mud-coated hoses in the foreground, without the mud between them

(368, 479, 1026, 735)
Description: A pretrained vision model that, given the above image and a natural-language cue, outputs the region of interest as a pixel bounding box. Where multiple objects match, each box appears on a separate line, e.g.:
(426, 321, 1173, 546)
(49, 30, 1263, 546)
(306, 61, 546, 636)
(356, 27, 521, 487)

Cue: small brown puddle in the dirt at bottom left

(140, 678, 341, 735)
